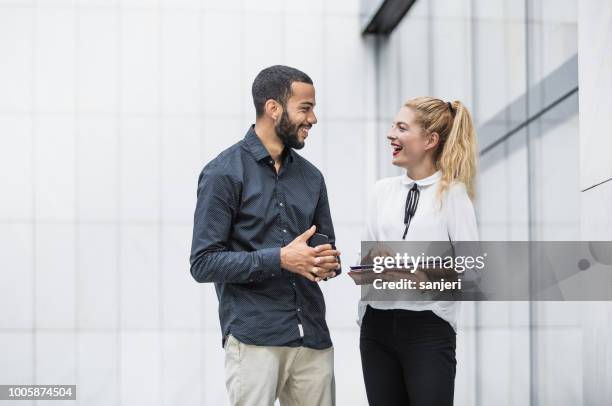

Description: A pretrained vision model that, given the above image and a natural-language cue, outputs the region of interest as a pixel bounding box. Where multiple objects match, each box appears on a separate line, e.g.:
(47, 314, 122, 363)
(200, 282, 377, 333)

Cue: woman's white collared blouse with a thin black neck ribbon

(357, 171, 478, 331)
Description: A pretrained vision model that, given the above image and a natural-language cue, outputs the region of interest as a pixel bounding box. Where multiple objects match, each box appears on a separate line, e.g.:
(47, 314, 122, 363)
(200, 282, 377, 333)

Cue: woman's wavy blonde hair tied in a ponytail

(404, 97, 476, 203)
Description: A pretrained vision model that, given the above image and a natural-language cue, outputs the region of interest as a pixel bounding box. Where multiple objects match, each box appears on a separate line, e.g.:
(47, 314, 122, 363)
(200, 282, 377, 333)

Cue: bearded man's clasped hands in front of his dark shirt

(281, 226, 340, 282)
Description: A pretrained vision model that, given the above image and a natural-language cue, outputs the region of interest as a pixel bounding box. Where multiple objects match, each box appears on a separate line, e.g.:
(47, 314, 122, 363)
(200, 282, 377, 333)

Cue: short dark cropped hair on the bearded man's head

(251, 65, 312, 117)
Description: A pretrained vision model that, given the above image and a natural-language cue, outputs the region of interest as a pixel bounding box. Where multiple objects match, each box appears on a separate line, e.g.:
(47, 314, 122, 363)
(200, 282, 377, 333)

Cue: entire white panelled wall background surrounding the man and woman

(0, 0, 612, 406)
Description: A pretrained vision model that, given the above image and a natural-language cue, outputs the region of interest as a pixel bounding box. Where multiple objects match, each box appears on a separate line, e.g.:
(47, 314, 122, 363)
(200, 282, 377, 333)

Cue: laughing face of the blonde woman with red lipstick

(387, 106, 437, 169)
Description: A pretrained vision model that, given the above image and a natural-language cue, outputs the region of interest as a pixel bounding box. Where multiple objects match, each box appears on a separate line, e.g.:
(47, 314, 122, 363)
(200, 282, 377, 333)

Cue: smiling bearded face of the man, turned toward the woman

(276, 82, 317, 149)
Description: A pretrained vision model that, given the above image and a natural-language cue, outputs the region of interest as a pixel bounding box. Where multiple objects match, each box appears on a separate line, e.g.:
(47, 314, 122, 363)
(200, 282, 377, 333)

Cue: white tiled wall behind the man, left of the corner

(0, 0, 375, 406)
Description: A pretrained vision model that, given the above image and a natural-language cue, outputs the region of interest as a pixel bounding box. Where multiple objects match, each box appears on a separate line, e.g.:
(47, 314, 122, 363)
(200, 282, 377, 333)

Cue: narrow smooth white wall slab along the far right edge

(578, 1, 612, 406)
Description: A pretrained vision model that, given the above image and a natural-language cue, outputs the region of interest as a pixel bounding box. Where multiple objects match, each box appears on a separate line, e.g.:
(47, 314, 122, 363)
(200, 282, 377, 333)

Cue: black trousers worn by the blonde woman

(360, 306, 457, 406)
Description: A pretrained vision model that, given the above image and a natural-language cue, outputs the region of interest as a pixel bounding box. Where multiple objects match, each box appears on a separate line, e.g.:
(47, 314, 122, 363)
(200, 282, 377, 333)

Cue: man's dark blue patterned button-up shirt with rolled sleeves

(190, 126, 335, 349)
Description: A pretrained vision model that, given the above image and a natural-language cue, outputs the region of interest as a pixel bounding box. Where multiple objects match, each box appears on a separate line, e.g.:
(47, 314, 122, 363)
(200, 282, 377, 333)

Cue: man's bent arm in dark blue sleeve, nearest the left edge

(190, 167, 281, 283)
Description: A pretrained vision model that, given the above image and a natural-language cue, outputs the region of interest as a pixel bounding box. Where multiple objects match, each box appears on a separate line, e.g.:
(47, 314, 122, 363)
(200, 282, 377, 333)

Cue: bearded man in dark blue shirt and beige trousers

(190, 66, 340, 406)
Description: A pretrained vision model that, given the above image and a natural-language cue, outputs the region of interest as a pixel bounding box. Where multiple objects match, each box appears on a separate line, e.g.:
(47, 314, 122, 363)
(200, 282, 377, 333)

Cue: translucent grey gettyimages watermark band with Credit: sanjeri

(349, 241, 612, 301)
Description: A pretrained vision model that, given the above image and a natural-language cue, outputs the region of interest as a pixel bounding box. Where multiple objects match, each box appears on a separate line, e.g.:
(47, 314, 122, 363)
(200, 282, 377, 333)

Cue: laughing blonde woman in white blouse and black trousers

(359, 97, 478, 406)
